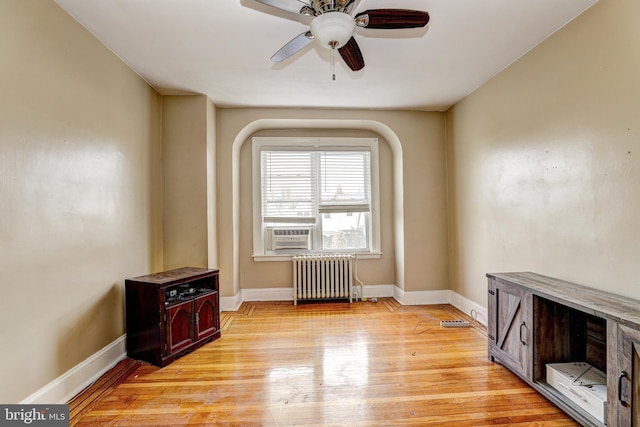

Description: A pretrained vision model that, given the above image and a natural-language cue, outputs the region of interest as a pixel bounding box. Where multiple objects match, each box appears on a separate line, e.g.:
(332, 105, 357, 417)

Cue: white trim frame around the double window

(251, 137, 382, 261)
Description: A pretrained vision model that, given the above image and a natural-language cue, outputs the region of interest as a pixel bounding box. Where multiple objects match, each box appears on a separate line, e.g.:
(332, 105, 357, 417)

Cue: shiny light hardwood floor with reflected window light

(70, 299, 577, 427)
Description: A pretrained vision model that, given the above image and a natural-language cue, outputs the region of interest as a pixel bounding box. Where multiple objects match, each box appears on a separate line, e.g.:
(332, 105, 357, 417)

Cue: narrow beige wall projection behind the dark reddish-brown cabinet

(162, 95, 216, 270)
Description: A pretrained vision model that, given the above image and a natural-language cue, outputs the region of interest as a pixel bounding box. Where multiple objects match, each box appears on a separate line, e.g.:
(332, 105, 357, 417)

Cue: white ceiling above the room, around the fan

(55, 0, 597, 111)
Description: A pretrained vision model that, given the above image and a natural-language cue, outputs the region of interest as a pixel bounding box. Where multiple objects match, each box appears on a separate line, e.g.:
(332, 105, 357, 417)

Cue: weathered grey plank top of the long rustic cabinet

(487, 272, 640, 328)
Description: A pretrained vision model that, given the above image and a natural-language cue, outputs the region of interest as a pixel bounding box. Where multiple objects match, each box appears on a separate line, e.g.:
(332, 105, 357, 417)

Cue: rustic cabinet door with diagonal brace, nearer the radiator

(488, 279, 533, 379)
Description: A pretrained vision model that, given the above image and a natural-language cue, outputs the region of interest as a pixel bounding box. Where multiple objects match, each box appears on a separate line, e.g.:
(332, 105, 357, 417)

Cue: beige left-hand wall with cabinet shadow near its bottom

(0, 0, 162, 403)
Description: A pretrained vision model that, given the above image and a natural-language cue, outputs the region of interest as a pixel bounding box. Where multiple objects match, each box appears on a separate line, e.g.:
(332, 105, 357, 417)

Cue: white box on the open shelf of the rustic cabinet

(546, 362, 607, 424)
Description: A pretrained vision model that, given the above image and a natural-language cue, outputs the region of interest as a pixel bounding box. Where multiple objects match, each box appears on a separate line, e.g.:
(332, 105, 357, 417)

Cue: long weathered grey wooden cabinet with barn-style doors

(487, 273, 640, 427)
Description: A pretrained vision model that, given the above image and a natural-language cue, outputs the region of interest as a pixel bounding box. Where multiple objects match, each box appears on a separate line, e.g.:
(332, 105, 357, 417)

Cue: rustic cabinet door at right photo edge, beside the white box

(610, 325, 640, 426)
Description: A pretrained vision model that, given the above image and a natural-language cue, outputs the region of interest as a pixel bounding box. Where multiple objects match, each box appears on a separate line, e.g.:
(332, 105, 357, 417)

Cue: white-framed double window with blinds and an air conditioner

(253, 138, 380, 257)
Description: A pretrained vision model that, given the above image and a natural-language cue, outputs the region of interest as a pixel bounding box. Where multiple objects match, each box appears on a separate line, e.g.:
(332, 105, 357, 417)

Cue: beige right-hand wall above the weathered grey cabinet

(447, 0, 640, 304)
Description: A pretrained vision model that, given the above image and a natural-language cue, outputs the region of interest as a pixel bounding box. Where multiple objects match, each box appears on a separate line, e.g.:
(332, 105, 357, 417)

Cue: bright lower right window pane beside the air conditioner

(322, 212, 369, 250)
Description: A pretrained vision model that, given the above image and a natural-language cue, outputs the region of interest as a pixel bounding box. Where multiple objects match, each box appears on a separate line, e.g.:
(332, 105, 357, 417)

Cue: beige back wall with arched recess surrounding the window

(217, 109, 448, 296)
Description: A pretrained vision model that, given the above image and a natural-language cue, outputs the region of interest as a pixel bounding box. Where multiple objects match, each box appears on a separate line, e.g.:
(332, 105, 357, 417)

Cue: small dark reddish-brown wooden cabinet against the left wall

(125, 267, 220, 367)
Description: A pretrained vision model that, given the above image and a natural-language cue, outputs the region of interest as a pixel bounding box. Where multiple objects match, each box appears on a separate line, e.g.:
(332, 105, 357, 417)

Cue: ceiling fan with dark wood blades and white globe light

(257, 0, 429, 72)
